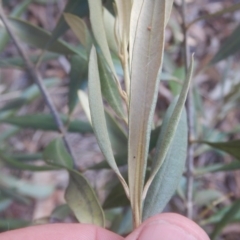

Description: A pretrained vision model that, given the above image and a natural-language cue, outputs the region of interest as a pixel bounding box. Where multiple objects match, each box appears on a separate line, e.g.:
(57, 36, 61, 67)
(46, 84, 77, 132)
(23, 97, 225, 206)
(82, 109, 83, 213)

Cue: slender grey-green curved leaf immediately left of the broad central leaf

(88, 47, 128, 195)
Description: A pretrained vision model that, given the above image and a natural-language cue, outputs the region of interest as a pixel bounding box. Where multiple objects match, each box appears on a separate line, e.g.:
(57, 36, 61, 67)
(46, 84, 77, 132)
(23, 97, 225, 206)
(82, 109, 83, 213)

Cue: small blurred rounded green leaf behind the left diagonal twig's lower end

(43, 138, 73, 169)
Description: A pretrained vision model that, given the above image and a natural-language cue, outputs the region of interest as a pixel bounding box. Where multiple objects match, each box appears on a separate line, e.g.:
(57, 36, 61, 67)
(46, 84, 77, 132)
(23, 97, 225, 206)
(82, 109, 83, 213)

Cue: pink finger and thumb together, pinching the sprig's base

(0, 213, 210, 240)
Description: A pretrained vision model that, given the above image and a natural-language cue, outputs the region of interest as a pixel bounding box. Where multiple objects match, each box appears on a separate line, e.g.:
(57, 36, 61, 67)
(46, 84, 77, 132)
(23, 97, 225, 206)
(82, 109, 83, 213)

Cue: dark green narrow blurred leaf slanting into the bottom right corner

(211, 200, 240, 240)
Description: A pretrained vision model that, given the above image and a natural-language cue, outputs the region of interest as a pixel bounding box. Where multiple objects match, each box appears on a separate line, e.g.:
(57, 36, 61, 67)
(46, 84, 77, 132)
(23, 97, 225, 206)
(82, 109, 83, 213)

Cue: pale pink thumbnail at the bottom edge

(138, 220, 197, 240)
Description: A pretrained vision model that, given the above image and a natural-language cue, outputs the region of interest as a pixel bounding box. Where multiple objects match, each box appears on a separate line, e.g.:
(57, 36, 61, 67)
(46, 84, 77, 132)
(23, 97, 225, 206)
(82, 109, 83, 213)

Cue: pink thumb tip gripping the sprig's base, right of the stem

(125, 213, 210, 240)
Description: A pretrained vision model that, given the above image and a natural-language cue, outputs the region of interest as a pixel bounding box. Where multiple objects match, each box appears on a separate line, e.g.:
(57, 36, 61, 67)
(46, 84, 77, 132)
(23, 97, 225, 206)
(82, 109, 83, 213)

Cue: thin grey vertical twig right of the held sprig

(181, 0, 195, 219)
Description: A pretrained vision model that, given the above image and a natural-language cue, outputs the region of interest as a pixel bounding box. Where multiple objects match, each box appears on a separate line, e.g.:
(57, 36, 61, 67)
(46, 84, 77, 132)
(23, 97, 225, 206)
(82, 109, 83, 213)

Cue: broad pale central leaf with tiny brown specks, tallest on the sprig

(128, 0, 166, 226)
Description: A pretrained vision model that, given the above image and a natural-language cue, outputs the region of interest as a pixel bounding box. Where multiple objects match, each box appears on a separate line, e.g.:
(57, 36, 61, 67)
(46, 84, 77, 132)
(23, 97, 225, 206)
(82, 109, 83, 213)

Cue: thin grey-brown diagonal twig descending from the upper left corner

(0, 2, 76, 168)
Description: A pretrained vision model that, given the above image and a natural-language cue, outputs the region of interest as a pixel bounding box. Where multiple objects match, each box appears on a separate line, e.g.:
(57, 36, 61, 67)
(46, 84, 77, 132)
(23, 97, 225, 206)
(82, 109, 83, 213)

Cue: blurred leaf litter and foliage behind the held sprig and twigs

(0, 0, 240, 240)
